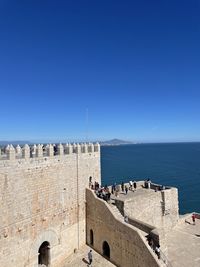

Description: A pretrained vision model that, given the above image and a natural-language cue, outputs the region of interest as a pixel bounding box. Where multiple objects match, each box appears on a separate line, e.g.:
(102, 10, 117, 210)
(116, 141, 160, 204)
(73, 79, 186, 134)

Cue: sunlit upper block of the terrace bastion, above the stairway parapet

(124, 188, 179, 232)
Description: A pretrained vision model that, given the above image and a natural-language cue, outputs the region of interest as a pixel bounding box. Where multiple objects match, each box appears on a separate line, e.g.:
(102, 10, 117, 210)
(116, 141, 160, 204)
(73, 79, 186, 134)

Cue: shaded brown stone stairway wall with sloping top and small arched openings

(86, 189, 160, 267)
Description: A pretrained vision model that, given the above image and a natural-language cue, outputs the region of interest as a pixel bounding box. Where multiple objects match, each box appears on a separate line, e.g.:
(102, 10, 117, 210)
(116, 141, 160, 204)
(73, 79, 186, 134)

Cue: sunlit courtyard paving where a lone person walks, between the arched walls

(63, 245, 115, 267)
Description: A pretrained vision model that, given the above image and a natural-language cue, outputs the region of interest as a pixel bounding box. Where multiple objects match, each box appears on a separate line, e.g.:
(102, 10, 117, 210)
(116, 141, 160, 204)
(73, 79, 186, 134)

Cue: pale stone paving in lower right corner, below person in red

(167, 214, 200, 267)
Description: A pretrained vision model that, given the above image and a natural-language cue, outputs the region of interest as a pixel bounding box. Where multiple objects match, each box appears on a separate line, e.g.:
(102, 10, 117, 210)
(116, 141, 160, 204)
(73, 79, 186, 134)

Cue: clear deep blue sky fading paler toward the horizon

(0, 0, 200, 142)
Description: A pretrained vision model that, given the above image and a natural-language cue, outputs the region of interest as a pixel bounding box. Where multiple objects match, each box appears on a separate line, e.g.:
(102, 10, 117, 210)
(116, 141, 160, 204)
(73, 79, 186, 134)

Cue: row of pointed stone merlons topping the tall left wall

(0, 143, 100, 160)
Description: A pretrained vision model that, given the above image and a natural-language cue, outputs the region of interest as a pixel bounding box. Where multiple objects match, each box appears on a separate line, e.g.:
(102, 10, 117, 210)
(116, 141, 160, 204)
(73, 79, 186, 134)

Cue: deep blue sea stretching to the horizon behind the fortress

(101, 143, 200, 214)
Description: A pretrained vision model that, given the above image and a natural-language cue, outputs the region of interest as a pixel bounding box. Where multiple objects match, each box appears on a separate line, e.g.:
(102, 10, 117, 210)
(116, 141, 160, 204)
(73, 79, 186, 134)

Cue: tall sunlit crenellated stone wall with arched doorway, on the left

(0, 143, 101, 267)
